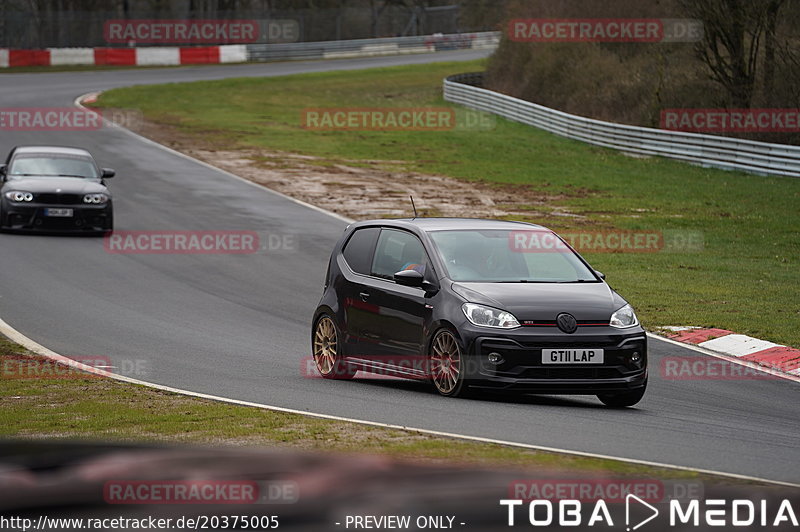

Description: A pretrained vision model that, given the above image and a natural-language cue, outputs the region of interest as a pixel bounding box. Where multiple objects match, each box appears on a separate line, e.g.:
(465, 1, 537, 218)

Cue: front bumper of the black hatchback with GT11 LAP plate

(462, 327, 647, 395)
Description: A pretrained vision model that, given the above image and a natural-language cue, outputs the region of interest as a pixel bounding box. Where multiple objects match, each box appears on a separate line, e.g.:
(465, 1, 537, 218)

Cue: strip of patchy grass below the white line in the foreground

(0, 336, 710, 479)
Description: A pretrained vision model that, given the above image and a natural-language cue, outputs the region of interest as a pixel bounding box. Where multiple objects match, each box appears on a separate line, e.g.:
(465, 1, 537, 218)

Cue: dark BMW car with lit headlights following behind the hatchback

(0, 146, 114, 234)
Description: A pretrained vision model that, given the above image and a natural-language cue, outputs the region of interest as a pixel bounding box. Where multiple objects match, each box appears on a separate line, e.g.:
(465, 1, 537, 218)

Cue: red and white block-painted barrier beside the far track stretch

(0, 44, 247, 68)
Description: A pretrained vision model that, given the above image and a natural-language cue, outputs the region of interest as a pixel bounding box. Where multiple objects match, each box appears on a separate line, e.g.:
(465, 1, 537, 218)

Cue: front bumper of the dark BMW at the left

(0, 202, 113, 233)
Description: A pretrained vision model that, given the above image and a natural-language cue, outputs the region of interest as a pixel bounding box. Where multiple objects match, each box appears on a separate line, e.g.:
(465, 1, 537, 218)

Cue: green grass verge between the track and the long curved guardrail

(99, 62, 800, 346)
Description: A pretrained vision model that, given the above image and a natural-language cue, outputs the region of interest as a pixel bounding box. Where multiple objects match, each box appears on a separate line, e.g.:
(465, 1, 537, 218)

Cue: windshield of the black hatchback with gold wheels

(430, 229, 600, 283)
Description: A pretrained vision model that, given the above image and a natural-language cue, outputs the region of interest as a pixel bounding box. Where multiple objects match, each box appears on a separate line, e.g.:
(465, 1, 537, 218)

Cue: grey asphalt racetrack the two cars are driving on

(0, 52, 800, 483)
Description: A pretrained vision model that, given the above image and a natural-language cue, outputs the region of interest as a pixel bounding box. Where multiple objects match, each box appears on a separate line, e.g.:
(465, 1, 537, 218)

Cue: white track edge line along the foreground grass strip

(0, 319, 800, 488)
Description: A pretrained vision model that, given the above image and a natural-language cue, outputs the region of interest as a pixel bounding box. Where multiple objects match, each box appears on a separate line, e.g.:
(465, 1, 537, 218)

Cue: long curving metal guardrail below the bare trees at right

(444, 73, 800, 177)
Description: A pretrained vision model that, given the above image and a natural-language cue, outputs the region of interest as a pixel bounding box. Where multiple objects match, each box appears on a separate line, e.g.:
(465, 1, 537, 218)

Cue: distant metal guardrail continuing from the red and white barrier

(247, 32, 500, 61)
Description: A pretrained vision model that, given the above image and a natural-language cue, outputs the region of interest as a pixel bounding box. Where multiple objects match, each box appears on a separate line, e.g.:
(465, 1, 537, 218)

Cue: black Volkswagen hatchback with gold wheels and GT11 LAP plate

(311, 218, 647, 407)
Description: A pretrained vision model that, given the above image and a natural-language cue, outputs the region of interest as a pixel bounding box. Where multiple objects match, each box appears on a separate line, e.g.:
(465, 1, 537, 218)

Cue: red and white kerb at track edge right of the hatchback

(663, 327, 800, 376)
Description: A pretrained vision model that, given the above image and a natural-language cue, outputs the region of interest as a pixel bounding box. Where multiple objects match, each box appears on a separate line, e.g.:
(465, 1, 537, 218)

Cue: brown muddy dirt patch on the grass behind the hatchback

(109, 109, 583, 222)
